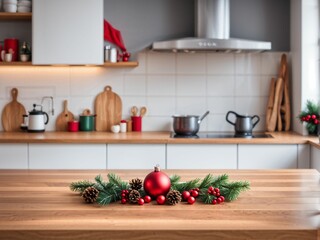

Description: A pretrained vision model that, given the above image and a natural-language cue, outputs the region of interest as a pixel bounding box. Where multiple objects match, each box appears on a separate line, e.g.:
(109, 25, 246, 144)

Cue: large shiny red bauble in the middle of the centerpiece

(143, 166, 171, 199)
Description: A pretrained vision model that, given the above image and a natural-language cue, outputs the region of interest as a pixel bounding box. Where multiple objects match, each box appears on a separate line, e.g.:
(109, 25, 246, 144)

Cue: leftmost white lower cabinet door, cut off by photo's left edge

(0, 143, 28, 169)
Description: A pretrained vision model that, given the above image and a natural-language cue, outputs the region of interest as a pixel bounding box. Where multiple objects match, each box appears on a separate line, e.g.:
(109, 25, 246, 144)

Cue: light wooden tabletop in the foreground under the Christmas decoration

(0, 169, 320, 240)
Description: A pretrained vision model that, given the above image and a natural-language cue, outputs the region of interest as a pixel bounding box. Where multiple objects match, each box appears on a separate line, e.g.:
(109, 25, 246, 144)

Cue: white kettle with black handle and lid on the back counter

(28, 104, 49, 132)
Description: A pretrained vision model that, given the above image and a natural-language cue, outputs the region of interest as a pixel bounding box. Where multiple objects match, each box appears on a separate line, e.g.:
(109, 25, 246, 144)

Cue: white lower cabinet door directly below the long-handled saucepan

(167, 144, 237, 169)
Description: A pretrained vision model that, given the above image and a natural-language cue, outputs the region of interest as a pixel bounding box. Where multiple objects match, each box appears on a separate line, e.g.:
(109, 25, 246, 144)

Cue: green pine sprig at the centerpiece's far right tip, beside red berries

(220, 181, 250, 202)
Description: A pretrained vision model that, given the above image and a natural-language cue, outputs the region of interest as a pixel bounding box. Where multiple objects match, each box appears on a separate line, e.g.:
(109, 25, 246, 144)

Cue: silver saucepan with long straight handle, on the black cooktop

(172, 111, 209, 136)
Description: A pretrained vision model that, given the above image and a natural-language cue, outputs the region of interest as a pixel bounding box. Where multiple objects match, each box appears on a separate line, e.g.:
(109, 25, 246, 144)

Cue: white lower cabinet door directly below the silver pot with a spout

(238, 144, 298, 169)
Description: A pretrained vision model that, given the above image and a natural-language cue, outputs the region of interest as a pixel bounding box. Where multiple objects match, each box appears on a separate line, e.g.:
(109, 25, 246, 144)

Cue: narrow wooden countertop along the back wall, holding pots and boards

(0, 132, 320, 148)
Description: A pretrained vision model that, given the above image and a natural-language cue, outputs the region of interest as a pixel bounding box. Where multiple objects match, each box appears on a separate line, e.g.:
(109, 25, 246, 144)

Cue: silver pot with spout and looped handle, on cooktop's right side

(226, 111, 260, 135)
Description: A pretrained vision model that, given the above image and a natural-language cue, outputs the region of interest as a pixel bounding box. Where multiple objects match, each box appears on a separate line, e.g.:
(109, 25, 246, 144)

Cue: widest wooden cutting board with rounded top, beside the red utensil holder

(94, 86, 122, 132)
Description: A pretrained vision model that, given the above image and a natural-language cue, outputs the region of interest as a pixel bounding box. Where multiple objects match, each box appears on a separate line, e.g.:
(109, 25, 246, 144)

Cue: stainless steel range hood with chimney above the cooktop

(151, 0, 271, 52)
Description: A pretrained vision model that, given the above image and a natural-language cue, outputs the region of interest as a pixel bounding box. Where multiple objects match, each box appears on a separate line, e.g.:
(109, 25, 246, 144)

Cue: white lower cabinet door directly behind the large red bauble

(108, 144, 166, 169)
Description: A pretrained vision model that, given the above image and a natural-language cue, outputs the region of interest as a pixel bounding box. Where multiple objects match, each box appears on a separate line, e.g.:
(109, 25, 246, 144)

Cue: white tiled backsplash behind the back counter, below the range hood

(0, 52, 282, 131)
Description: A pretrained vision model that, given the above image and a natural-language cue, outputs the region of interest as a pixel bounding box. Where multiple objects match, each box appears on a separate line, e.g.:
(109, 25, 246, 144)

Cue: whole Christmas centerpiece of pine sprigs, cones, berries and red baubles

(70, 166, 250, 205)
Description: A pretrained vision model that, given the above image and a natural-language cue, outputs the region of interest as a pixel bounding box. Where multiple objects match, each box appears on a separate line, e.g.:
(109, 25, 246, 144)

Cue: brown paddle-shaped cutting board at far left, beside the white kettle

(1, 88, 26, 132)
